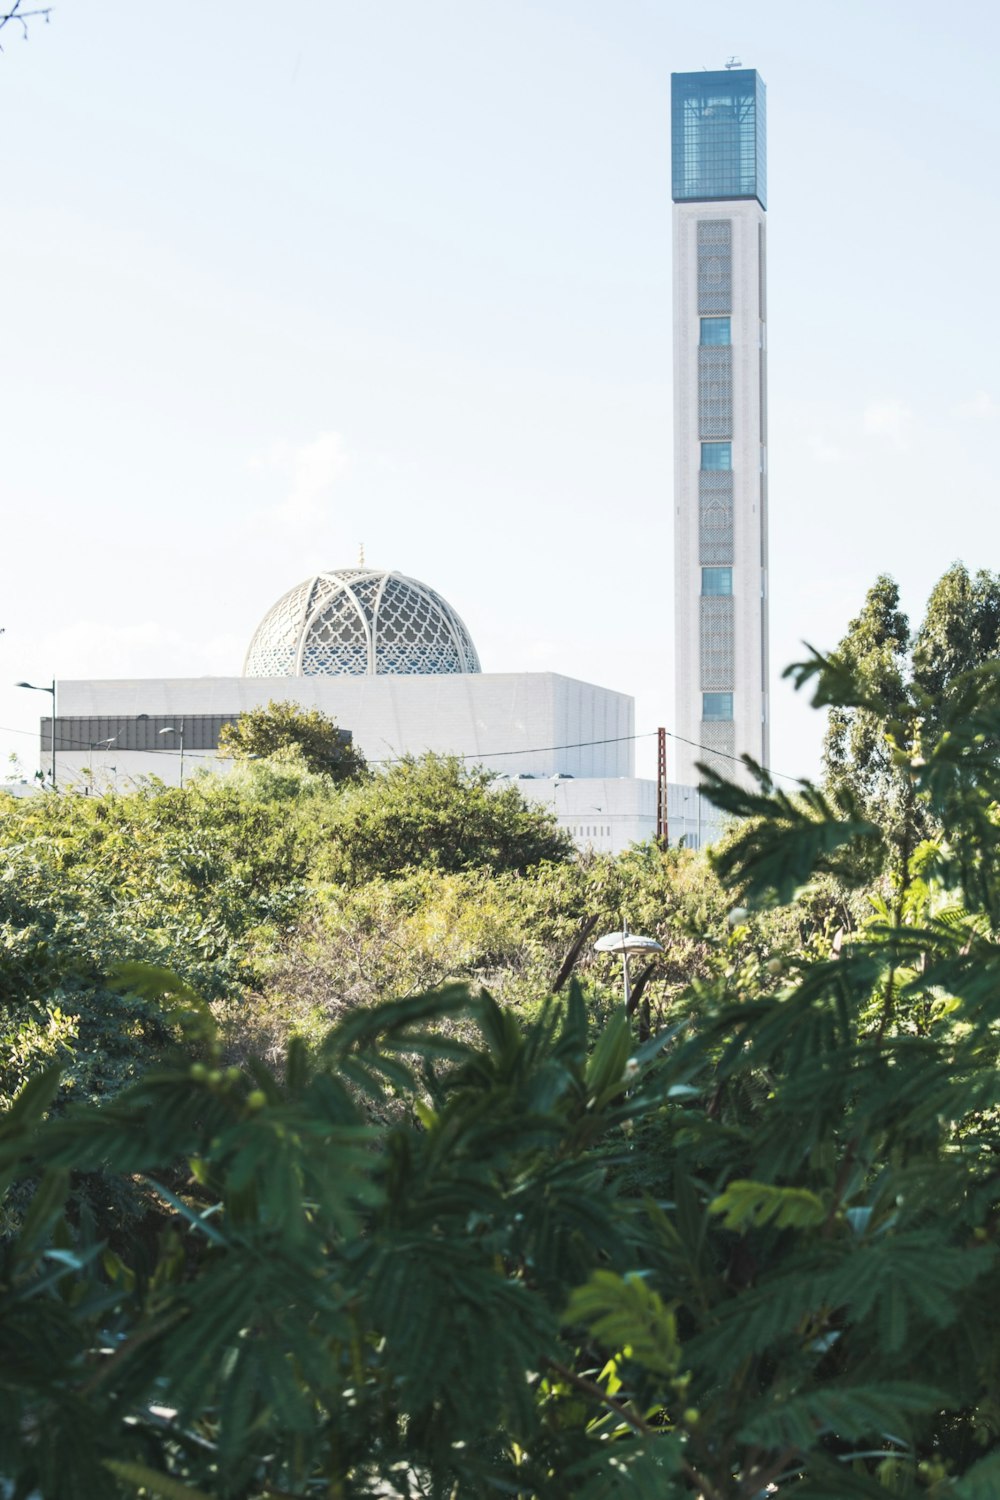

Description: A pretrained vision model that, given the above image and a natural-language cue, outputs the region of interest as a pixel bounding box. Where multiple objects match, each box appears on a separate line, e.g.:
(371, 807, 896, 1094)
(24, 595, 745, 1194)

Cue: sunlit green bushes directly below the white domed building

(0, 741, 571, 1107)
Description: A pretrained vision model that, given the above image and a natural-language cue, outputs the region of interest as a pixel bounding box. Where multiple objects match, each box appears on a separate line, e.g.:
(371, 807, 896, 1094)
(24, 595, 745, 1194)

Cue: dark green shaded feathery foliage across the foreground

(7, 665, 1000, 1500)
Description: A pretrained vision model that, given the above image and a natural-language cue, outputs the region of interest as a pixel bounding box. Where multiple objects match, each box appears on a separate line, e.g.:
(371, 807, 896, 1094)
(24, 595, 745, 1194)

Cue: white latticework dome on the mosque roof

(243, 567, 481, 677)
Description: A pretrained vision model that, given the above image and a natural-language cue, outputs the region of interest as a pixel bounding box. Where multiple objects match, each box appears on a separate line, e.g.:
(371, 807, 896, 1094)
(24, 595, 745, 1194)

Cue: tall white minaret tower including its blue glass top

(672, 69, 769, 783)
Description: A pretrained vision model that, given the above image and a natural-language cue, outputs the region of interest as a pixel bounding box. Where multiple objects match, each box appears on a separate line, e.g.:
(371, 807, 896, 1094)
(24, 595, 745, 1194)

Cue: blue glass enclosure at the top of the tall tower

(670, 68, 768, 209)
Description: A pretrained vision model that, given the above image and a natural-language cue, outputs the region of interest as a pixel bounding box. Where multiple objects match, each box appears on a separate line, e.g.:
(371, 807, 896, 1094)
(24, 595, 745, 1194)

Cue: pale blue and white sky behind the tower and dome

(0, 0, 1000, 776)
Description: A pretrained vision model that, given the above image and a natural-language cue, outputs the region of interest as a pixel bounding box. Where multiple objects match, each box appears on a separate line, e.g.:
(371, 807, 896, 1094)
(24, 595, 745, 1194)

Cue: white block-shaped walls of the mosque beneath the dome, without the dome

(37, 672, 728, 854)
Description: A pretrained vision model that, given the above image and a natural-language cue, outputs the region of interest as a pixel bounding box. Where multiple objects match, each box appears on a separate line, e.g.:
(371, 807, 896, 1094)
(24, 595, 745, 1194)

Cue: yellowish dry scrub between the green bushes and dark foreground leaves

(225, 845, 743, 1058)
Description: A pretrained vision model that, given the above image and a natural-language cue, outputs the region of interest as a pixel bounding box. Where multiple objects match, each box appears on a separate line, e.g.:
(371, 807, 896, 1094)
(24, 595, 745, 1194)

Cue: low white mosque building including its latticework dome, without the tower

(40, 566, 718, 854)
